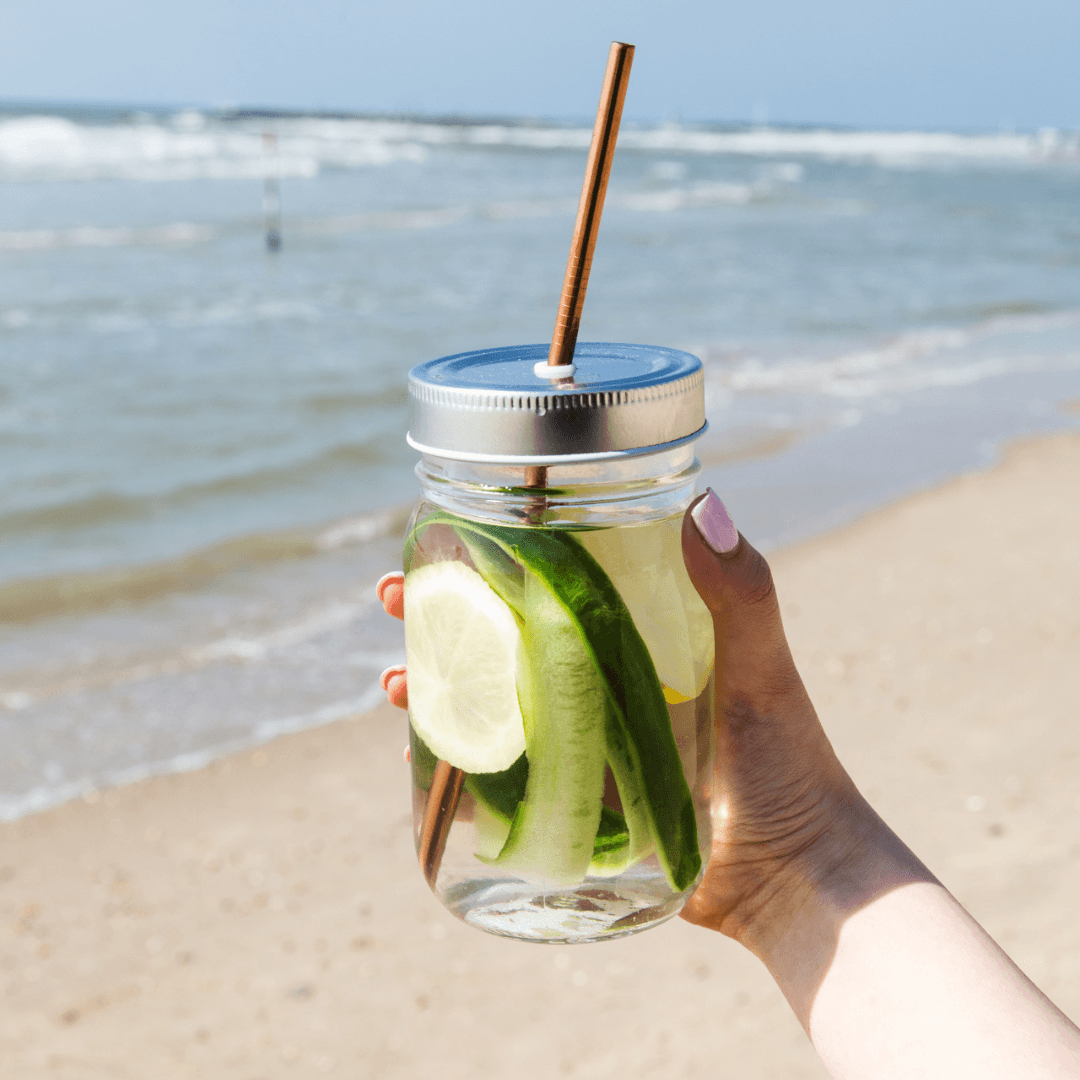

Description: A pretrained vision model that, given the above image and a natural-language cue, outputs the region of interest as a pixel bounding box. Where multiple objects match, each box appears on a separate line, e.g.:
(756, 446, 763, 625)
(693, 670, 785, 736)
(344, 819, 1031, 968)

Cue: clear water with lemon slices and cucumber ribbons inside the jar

(405, 502, 713, 943)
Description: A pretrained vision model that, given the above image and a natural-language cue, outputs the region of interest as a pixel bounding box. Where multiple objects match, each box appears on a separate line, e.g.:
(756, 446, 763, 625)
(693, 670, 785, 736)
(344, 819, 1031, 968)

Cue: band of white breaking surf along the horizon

(0, 111, 1080, 181)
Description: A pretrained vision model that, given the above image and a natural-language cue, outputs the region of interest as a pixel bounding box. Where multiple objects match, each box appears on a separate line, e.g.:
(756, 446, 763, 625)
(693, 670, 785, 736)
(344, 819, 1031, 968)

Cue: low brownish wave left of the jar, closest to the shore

(0, 505, 411, 622)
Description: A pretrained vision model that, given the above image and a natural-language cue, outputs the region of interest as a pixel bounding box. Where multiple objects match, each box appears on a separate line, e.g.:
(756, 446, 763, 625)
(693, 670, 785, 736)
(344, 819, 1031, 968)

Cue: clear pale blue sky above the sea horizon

(0, 0, 1080, 131)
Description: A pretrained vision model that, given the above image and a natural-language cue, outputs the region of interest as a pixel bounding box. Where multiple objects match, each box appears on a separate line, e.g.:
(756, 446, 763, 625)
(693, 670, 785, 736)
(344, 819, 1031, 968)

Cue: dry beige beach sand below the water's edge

(0, 436, 1080, 1080)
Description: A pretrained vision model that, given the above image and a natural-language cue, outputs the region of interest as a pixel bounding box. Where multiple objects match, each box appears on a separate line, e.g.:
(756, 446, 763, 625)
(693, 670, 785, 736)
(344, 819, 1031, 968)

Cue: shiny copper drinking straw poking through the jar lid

(412, 41, 634, 888)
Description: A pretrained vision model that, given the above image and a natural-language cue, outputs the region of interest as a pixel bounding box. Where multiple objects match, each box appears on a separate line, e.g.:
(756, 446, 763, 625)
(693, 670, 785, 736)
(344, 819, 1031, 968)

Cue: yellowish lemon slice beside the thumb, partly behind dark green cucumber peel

(573, 516, 714, 703)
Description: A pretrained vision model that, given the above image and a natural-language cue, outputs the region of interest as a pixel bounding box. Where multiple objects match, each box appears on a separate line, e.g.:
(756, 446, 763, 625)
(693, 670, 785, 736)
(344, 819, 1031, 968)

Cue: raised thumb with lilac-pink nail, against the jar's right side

(683, 488, 801, 713)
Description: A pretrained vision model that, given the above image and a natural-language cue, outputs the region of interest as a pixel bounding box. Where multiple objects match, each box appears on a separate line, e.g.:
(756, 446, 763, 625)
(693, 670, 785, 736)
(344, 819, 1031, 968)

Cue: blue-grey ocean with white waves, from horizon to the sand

(0, 109, 1080, 820)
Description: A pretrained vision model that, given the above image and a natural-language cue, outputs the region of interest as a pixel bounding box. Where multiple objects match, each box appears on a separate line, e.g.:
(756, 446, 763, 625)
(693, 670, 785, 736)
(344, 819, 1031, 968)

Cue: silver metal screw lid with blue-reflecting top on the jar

(407, 341, 706, 464)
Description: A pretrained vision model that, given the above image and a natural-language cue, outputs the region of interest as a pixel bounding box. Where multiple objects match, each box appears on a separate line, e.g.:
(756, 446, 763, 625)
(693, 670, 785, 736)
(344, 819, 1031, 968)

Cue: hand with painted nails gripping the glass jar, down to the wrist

(376, 495, 894, 948)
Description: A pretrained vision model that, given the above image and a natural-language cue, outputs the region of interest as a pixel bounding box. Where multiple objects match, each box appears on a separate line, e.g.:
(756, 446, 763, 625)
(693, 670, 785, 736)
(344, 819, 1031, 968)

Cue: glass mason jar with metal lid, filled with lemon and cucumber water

(404, 343, 714, 943)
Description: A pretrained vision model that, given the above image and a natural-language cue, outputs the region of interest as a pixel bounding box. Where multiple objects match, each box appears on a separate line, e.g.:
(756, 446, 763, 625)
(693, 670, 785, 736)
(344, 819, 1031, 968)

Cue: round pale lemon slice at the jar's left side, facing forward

(405, 562, 525, 772)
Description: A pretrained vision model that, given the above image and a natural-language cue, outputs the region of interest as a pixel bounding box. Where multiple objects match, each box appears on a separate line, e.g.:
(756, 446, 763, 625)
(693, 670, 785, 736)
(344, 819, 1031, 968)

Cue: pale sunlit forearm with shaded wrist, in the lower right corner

(740, 805, 1080, 1080)
